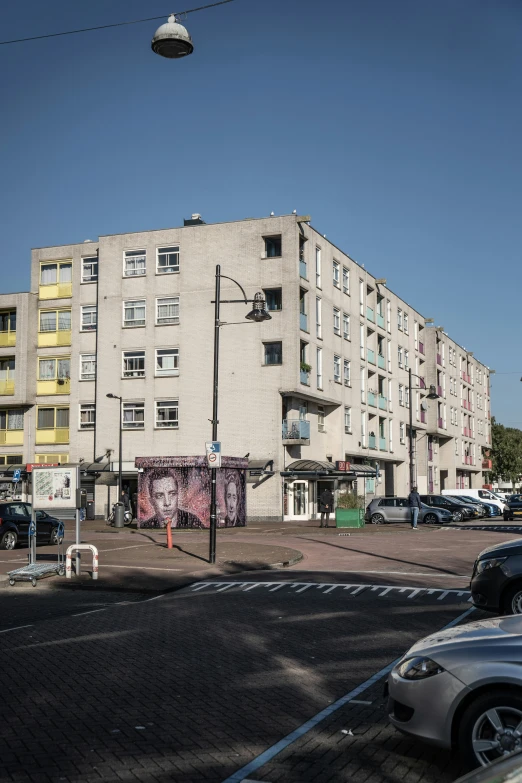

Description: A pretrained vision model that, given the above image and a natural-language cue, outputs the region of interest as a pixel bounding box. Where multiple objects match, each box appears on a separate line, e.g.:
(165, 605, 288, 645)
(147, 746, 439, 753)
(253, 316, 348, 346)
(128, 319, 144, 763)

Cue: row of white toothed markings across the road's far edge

(188, 581, 472, 603)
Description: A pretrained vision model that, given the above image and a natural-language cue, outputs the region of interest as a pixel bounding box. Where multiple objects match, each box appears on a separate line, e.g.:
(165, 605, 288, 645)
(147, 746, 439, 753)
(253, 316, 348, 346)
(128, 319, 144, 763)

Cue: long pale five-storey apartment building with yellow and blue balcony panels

(0, 215, 489, 519)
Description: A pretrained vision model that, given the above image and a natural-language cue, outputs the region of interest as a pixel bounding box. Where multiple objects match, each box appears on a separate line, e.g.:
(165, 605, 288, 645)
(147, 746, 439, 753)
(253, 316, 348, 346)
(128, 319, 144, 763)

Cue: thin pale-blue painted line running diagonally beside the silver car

(219, 607, 474, 783)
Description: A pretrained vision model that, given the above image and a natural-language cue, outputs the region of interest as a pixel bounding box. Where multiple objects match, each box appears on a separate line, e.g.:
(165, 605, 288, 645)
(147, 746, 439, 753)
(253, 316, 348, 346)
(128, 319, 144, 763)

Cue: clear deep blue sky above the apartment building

(0, 0, 522, 428)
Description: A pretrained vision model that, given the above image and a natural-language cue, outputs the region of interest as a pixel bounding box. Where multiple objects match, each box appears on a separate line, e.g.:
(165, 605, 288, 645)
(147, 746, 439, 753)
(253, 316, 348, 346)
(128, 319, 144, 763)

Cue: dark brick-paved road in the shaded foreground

(0, 574, 482, 783)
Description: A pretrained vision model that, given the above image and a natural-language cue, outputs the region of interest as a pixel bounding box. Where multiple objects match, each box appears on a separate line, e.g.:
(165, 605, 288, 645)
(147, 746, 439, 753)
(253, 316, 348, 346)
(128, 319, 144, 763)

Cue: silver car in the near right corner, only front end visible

(388, 615, 522, 769)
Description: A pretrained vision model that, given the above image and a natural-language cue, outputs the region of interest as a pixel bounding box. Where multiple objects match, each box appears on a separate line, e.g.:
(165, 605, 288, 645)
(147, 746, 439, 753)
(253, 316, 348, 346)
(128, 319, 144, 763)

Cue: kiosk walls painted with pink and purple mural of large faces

(135, 457, 248, 528)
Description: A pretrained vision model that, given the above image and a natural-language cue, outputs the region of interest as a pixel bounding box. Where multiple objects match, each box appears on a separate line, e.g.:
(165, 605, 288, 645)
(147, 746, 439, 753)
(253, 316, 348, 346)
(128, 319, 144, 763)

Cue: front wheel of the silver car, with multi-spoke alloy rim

(458, 689, 522, 769)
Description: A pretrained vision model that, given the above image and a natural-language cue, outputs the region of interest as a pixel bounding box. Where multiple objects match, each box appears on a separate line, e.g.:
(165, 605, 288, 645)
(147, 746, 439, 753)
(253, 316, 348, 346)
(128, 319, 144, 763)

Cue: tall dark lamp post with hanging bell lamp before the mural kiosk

(208, 264, 272, 563)
